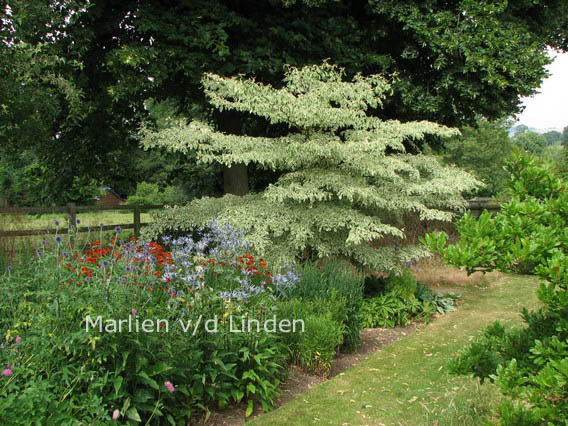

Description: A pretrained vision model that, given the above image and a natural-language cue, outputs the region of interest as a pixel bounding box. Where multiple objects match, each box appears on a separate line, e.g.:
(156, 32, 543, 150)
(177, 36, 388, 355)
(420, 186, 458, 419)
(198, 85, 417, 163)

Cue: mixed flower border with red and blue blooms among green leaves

(0, 224, 294, 424)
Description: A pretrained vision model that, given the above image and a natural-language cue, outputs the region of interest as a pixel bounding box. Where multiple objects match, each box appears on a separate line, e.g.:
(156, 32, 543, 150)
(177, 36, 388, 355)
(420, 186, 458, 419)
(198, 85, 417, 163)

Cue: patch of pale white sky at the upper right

(517, 53, 568, 128)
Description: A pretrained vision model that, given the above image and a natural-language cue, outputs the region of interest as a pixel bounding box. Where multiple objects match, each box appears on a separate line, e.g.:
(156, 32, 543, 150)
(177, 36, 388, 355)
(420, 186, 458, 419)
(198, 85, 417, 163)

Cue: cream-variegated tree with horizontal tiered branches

(142, 63, 480, 271)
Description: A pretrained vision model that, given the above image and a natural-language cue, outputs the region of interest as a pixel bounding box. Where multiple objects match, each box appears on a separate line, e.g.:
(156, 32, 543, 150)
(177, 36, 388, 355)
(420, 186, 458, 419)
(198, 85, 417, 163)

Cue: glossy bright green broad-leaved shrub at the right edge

(426, 154, 568, 425)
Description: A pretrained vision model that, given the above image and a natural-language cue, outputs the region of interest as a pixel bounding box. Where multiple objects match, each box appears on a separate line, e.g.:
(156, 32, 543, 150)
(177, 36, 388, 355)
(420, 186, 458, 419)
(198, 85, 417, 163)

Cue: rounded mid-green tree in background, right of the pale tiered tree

(443, 120, 513, 197)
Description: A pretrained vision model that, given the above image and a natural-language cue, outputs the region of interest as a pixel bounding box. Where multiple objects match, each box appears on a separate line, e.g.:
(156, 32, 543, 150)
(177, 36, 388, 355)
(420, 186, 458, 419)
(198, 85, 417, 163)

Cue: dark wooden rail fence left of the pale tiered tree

(0, 203, 164, 238)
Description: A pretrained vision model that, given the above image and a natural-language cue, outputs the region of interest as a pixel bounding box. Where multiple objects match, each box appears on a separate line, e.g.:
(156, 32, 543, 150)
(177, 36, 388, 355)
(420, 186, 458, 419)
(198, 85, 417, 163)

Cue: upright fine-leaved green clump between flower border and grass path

(285, 261, 363, 350)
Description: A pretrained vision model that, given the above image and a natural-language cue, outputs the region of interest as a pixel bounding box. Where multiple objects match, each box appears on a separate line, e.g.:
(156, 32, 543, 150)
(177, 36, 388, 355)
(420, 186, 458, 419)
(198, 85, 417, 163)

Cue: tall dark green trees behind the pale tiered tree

(0, 0, 568, 205)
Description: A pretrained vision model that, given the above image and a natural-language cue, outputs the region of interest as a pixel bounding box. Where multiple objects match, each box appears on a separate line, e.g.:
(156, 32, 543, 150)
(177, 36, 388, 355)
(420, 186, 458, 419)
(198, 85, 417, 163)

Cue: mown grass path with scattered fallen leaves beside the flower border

(250, 277, 538, 426)
